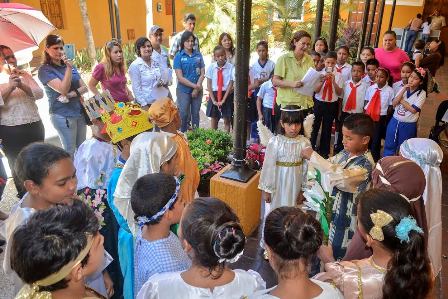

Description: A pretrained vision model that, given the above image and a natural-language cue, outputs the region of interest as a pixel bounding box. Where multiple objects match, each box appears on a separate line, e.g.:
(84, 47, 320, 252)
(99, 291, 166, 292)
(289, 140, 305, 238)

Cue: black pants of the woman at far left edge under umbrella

(0, 121, 45, 198)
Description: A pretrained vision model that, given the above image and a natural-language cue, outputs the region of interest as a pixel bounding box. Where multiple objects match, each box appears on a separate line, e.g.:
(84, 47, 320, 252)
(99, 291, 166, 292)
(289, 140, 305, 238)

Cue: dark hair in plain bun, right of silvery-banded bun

(264, 207, 323, 278)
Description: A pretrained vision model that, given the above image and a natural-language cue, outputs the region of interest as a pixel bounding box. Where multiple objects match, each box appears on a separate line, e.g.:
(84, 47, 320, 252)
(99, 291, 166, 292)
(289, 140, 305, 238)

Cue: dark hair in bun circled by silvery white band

(180, 197, 246, 279)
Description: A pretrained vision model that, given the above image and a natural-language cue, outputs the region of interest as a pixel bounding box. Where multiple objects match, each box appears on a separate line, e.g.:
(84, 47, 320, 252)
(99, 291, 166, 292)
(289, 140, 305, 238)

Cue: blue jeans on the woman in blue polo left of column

(176, 89, 202, 132)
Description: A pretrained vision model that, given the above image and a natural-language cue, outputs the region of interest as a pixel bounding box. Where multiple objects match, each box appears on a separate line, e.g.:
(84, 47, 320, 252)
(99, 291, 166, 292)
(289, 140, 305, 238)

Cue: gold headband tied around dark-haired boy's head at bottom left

(15, 235, 93, 299)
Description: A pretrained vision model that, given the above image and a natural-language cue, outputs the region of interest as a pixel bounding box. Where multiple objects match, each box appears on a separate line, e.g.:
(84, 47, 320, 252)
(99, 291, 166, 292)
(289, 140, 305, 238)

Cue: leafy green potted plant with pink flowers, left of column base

(187, 128, 232, 196)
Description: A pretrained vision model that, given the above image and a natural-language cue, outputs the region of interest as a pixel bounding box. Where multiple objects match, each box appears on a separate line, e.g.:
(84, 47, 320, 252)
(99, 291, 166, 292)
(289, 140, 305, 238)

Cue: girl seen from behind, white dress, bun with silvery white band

(137, 198, 265, 299)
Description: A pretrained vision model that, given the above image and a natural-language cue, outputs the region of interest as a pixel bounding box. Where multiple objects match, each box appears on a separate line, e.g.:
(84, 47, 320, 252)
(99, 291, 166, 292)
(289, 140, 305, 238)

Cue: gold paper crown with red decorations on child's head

(101, 102, 153, 143)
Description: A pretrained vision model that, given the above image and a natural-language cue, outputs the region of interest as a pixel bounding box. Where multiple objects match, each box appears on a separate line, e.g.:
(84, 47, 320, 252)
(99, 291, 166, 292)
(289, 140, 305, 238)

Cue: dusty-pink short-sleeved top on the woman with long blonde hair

(92, 63, 129, 102)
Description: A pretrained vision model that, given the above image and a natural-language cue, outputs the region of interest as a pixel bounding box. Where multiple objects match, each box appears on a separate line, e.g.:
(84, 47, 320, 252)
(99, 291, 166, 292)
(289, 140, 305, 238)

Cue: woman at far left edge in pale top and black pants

(0, 45, 45, 199)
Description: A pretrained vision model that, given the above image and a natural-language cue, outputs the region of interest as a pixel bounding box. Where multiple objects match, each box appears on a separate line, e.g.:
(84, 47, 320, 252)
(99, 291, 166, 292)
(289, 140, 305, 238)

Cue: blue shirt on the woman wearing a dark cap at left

(38, 64, 82, 117)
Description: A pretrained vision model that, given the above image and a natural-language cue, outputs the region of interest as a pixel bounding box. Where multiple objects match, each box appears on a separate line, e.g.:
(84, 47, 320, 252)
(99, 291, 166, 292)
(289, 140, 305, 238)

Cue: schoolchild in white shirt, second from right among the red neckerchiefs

(336, 61, 368, 153)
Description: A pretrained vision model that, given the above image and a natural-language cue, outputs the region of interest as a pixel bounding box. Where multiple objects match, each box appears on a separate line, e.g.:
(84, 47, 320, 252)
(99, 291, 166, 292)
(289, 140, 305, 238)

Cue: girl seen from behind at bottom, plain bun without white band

(254, 207, 344, 299)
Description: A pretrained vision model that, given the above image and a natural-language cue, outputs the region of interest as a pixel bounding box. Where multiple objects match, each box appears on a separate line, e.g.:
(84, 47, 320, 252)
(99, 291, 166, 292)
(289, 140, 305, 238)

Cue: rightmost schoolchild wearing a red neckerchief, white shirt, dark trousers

(365, 68, 394, 162)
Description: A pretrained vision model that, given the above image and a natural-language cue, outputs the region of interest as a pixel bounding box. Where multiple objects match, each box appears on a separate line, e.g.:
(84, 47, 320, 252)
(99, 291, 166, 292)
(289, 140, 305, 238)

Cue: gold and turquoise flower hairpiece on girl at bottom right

(369, 210, 423, 243)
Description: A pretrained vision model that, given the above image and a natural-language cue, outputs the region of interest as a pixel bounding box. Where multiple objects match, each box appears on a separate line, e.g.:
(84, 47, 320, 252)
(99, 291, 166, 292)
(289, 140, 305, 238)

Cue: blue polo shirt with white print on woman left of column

(173, 50, 205, 93)
